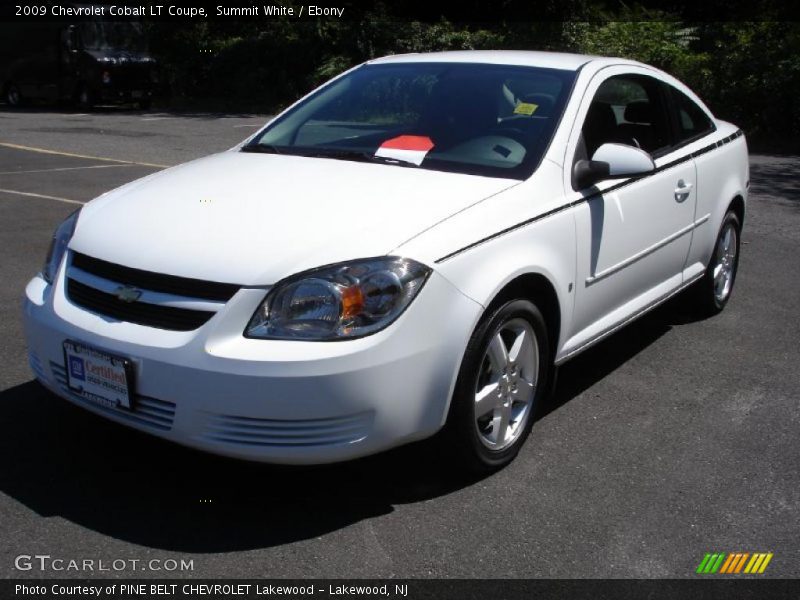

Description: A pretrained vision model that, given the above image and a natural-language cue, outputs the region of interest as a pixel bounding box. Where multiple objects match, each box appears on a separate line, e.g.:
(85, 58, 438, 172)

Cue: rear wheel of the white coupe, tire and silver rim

(692, 211, 742, 316)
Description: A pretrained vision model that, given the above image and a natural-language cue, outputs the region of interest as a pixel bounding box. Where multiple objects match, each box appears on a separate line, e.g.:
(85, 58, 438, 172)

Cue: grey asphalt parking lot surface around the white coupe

(0, 109, 800, 578)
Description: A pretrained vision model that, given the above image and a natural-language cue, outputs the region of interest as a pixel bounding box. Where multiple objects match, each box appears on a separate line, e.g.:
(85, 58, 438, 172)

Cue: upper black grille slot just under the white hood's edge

(72, 252, 239, 302)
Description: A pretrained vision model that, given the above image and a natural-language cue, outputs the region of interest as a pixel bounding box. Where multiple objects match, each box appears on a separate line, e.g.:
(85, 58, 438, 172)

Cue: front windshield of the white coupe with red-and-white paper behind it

(248, 63, 575, 179)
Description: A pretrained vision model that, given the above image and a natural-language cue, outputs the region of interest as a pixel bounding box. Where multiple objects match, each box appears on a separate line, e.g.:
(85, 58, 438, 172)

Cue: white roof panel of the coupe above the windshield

(369, 50, 641, 71)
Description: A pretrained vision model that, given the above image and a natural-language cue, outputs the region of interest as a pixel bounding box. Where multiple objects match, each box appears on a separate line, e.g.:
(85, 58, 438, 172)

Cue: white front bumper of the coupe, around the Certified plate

(24, 265, 482, 464)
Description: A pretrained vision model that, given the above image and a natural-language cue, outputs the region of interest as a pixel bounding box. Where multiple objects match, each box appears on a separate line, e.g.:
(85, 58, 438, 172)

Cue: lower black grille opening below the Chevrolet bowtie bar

(67, 278, 215, 331)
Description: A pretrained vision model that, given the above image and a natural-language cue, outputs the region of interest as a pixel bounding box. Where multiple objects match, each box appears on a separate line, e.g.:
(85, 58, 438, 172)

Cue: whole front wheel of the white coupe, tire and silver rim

(444, 300, 552, 473)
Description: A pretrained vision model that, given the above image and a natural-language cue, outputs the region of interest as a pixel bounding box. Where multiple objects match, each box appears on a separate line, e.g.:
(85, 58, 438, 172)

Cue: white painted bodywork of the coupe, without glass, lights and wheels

(24, 51, 749, 464)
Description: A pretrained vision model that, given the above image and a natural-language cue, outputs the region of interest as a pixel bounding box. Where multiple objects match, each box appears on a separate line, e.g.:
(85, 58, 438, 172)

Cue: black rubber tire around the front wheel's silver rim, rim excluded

(448, 300, 551, 471)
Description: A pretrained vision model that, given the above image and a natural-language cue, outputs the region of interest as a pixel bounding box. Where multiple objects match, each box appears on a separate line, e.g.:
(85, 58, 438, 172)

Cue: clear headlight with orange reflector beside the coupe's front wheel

(244, 257, 431, 340)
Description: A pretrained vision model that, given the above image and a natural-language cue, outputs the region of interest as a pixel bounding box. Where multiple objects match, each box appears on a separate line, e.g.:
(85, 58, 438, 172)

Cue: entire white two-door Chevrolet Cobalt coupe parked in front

(24, 52, 749, 469)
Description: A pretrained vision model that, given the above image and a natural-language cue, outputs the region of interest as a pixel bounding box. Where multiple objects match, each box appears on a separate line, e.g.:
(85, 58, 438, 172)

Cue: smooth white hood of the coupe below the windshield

(70, 151, 518, 285)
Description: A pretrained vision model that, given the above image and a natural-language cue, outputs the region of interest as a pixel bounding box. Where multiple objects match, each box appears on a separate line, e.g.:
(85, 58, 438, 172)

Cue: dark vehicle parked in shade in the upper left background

(0, 19, 157, 109)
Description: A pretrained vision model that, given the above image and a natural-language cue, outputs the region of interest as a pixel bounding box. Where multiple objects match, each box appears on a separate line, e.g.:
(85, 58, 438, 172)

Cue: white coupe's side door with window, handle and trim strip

(567, 68, 696, 349)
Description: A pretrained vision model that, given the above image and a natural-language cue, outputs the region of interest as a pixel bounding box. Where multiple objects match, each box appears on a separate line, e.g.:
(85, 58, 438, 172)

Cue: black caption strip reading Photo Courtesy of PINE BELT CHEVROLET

(0, 578, 800, 600)
